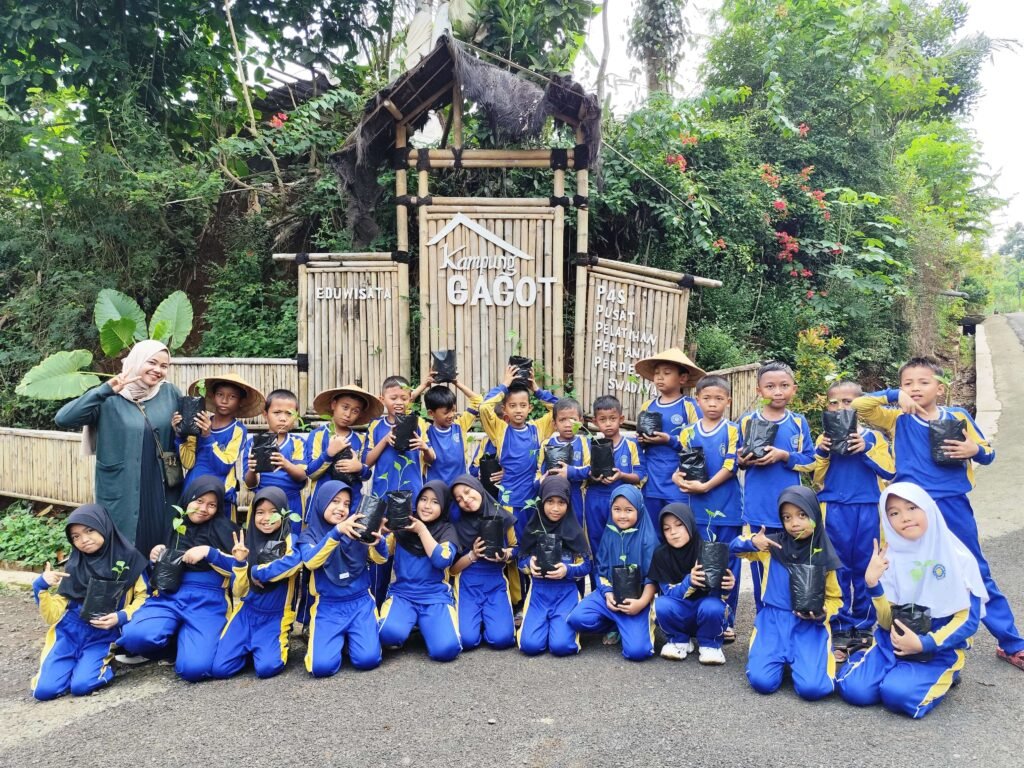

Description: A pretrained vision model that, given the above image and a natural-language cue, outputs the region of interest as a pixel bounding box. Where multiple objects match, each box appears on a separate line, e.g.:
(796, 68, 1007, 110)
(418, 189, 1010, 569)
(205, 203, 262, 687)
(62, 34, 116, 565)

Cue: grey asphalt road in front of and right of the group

(0, 315, 1024, 768)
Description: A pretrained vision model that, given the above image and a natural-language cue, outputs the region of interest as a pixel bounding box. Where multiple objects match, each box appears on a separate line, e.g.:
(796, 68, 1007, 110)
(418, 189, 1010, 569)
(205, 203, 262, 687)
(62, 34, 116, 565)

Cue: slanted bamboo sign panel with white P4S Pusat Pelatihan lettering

(574, 259, 690, 422)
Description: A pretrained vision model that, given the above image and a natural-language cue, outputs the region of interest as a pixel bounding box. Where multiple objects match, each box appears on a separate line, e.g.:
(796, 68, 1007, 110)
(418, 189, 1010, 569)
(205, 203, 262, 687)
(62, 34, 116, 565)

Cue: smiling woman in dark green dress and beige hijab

(55, 339, 181, 557)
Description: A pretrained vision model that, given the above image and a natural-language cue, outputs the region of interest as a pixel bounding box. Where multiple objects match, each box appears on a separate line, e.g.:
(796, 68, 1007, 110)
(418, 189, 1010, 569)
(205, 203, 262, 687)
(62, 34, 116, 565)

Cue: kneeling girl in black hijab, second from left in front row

(118, 475, 243, 683)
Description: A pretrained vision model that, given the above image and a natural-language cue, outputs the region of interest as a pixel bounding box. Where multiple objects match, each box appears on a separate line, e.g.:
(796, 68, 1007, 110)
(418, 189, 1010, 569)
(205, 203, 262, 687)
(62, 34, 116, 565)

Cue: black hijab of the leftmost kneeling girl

(57, 504, 150, 600)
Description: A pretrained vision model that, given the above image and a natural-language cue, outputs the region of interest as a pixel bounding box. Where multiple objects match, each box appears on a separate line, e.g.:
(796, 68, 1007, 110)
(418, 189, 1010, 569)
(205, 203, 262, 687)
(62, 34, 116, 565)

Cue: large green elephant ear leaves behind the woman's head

(14, 288, 193, 400)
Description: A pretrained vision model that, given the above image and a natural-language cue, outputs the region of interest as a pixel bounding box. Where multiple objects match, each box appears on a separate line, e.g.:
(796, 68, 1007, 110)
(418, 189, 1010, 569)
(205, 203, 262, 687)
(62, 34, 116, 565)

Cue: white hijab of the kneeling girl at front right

(879, 482, 988, 618)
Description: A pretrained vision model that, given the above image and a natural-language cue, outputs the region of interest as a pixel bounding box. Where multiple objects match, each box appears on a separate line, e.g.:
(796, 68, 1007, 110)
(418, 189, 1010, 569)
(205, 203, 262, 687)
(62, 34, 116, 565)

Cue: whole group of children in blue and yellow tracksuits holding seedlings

(33, 348, 1024, 717)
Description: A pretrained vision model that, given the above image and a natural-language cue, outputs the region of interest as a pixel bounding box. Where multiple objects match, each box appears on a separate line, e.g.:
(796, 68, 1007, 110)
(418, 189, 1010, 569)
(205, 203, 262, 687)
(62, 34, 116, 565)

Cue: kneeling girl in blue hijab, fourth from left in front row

(299, 480, 383, 677)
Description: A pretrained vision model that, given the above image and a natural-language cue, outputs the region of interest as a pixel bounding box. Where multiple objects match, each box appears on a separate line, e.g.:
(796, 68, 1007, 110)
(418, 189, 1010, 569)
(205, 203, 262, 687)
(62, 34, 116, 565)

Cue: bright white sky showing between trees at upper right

(577, 0, 1024, 250)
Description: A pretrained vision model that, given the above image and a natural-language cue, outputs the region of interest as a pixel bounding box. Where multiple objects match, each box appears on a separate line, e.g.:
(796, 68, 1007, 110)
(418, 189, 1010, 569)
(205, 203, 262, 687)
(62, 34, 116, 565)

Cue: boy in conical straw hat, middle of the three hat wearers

(305, 384, 384, 518)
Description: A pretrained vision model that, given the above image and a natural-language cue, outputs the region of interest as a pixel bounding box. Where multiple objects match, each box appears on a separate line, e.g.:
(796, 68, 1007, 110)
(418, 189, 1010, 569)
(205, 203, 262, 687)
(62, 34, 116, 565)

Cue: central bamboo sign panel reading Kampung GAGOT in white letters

(419, 199, 565, 392)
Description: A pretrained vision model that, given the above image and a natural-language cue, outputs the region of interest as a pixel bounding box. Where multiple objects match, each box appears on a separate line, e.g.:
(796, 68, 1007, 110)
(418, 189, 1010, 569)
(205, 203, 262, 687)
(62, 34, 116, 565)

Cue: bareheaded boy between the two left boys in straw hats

(242, 389, 307, 541)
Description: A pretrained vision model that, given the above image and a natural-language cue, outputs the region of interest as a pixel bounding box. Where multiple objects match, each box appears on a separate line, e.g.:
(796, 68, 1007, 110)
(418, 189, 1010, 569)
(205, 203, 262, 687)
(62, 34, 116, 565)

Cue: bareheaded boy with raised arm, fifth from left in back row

(421, 379, 483, 485)
